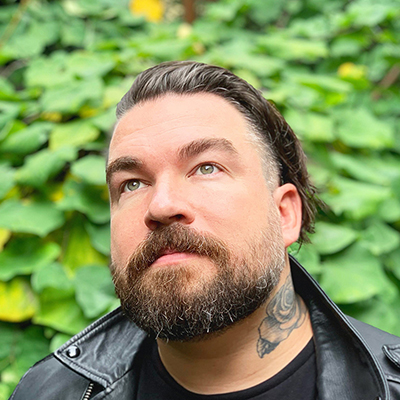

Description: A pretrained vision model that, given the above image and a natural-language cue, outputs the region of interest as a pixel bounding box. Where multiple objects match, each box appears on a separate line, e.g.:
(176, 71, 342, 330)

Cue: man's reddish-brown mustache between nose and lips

(127, 223, 230, 272)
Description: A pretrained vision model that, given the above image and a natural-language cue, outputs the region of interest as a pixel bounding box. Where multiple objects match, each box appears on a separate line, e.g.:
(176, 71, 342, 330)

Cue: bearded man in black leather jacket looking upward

(12, 62, 400, 400)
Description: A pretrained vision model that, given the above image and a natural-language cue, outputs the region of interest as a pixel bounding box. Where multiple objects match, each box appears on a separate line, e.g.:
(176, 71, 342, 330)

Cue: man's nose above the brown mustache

(145, 182, 194, 230)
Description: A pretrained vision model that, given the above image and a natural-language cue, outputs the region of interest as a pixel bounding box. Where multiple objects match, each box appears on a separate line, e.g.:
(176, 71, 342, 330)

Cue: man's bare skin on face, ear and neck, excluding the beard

(107, 94, 312, 394)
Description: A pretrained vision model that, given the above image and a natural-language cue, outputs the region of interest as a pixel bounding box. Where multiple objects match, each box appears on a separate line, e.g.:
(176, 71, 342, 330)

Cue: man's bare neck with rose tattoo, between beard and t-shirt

(158, 264, 312, 394)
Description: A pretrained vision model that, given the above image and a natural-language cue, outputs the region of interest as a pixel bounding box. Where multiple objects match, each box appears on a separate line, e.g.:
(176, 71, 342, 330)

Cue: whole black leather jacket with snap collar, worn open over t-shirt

(10, 258, 400, 400)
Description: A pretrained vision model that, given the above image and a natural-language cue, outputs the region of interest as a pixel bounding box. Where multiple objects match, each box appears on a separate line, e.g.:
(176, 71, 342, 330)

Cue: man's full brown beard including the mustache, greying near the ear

(111, 212, 285, 341)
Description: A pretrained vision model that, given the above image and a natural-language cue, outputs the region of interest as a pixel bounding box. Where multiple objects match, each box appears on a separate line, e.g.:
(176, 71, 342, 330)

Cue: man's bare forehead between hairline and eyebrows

(110, 93, 253, 161)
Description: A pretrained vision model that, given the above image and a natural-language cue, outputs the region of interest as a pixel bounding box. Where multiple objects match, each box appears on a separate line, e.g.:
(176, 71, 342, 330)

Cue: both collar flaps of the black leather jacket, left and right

(54, 257, 389, 400)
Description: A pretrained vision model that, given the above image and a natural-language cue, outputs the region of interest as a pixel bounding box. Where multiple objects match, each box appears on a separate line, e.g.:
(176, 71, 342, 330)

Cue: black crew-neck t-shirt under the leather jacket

(138, 340, 317, 400)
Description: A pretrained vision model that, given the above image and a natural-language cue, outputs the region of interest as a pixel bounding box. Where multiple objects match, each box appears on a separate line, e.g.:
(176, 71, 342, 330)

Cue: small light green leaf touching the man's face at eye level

(71, 155, 106, 185)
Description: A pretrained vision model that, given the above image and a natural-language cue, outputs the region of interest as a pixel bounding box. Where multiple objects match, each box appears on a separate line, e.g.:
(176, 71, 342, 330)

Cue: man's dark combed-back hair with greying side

(117, 61, 319, 244)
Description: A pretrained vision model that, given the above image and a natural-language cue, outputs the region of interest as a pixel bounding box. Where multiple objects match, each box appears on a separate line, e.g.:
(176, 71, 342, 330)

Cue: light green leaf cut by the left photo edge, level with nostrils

(0, 200, 64, 236)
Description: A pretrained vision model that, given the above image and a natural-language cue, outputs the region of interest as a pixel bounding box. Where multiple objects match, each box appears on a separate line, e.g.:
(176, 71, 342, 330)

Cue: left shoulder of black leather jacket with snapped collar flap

(10, 309, 150, 400)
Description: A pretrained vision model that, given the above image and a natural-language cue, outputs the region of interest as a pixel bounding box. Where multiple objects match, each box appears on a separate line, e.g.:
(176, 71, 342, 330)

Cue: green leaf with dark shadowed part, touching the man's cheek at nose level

(58, 180, 110, 224)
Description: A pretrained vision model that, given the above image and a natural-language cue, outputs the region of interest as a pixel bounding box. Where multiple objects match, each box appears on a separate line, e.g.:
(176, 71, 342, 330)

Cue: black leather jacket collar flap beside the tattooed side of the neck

(290, 257, 390, 400)
